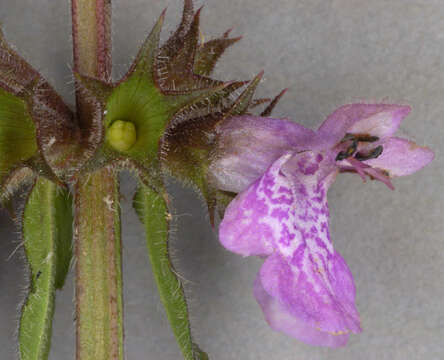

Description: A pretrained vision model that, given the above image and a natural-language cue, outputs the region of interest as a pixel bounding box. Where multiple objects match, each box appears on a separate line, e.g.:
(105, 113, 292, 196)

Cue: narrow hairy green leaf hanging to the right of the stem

(134, 185, 208, 360)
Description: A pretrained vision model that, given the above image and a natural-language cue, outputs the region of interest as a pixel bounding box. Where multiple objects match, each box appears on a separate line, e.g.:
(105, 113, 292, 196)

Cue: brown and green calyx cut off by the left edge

(0, 29, 79, 202)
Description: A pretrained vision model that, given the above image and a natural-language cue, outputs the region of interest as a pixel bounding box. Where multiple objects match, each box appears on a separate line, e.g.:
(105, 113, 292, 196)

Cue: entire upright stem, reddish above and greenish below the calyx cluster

(72, 0, 123, 360)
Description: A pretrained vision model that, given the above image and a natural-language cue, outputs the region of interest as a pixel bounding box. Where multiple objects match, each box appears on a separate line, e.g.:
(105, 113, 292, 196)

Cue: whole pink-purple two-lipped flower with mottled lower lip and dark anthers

(210, 104, 433, 347)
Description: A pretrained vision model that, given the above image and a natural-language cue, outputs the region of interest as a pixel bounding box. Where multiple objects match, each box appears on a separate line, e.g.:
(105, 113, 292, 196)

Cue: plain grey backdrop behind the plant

(0, 0, 444, 360)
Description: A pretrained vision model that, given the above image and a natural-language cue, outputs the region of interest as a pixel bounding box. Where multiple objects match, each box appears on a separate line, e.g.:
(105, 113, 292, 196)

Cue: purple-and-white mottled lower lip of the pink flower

(219, 151, 361, 347)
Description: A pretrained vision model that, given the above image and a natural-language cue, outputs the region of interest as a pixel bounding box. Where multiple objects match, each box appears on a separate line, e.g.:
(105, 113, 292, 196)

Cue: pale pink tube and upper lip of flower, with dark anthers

(209, 104, 434, 192)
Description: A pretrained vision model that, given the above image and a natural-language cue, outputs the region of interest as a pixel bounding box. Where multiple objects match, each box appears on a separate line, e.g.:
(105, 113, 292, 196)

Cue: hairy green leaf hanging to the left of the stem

(19, 178, 73, 360)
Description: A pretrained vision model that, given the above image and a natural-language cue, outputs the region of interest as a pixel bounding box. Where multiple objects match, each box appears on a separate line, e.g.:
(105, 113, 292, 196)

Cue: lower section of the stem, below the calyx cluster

(75, 169, 123, 360)
